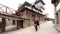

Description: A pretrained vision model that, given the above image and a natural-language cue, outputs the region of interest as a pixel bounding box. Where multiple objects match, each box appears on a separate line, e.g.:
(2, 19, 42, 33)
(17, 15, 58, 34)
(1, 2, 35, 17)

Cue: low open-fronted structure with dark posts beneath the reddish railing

(0, 13, 29, 32)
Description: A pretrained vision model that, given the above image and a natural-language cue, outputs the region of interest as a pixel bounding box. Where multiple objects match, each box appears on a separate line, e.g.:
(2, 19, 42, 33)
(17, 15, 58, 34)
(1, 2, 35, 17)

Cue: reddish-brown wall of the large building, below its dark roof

(17, 7, 44, 26)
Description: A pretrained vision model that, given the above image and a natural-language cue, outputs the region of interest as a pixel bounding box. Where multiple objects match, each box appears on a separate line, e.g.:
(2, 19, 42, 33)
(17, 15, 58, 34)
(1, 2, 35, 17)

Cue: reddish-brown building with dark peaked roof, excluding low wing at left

(16, 2, 45, 27)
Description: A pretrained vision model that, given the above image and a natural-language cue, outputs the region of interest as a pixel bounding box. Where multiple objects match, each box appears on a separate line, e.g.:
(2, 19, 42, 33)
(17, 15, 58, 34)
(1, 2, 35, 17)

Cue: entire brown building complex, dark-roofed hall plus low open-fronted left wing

(0, 2, 45, 32)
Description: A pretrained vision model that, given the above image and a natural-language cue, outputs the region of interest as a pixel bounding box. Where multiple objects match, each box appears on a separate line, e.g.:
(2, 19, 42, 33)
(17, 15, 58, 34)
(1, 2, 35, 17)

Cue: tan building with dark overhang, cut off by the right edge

(52, 0, 60, 31)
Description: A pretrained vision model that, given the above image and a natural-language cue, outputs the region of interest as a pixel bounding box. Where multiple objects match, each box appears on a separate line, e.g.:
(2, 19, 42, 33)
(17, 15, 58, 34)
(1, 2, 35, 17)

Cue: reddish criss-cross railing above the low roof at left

(0, 4, 16, 14)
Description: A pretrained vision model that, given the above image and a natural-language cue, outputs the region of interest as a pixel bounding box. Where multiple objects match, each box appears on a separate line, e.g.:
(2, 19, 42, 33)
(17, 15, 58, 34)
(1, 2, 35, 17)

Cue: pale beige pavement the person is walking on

(1, 21, 60, 34)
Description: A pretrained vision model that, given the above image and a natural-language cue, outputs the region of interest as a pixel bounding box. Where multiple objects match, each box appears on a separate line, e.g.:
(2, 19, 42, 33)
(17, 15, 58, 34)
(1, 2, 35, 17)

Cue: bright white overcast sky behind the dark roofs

(0, 0, 54, 18)
